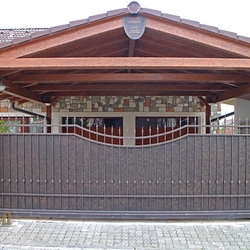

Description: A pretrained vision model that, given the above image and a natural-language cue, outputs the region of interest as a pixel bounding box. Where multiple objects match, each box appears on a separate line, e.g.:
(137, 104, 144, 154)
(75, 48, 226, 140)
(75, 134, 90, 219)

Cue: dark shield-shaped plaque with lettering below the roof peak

(123, 15, 146, 40)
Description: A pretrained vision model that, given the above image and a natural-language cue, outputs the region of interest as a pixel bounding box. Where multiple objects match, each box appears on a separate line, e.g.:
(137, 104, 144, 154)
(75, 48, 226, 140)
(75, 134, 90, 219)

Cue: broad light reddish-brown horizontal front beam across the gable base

(0, 57, 250, 71)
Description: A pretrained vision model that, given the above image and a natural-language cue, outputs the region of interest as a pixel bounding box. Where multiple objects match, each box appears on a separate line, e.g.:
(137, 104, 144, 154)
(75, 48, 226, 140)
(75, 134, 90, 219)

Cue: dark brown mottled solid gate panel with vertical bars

(0, 134, 250, 218)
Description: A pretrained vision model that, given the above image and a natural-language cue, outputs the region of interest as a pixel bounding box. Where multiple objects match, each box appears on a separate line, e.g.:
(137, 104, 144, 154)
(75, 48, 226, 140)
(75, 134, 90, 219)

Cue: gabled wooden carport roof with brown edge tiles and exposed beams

(0, 1, 250, 103)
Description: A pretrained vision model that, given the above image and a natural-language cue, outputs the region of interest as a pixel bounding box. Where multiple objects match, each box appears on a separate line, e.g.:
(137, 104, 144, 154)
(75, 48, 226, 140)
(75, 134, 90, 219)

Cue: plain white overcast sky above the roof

(0, 0, 250, 37)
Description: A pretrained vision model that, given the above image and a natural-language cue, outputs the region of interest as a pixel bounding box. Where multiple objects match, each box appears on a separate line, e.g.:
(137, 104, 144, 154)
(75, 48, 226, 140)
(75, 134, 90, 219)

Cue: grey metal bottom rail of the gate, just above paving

(0, 209, 250, 220)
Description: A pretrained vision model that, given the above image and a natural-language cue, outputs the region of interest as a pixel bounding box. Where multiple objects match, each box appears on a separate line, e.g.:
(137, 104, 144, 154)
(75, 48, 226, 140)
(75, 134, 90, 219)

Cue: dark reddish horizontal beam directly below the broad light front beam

(7, 73, 250, 83)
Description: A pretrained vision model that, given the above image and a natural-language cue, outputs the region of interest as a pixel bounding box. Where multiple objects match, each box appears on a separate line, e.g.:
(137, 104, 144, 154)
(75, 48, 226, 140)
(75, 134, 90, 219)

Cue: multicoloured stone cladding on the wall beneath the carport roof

(0, 96, 220, 117)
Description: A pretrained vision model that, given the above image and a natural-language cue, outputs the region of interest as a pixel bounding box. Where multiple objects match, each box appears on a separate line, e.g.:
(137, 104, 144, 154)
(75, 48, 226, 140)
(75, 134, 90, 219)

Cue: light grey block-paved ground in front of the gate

(0, 219, 250, 250)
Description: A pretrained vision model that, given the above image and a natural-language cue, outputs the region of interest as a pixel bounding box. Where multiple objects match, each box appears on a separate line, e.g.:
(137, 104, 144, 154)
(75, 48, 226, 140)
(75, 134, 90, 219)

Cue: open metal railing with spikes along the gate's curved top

(0, 116, 250, 146)
